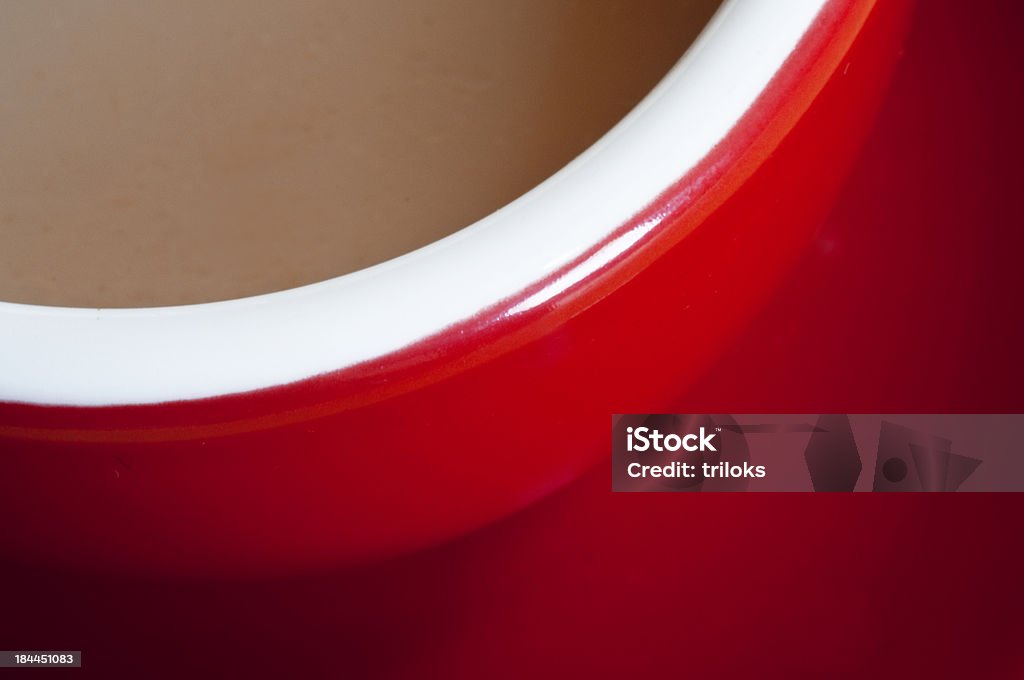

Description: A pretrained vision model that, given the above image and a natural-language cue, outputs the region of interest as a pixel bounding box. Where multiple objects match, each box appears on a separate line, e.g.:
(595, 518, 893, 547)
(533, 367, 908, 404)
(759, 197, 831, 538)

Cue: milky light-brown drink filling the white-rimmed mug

(0, 0, 718, 307)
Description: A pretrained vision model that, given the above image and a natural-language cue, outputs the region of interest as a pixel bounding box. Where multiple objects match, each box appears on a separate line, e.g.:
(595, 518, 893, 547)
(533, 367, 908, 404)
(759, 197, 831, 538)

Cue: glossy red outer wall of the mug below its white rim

(0, 0, 910, 572)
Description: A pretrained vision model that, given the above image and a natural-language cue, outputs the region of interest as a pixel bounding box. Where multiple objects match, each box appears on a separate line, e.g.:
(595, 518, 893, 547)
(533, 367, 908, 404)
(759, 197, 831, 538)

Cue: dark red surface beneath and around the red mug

(0, 0, 1024, 680)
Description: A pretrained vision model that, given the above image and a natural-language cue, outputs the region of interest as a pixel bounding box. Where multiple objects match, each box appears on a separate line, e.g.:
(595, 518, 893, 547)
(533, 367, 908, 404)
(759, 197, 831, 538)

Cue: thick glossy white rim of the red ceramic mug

(0, 0, 827, 406)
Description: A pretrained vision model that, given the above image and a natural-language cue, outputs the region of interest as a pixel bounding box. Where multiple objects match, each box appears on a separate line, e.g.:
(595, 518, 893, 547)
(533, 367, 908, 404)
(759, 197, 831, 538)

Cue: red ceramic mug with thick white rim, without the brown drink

(0, 0, 910, 572)
